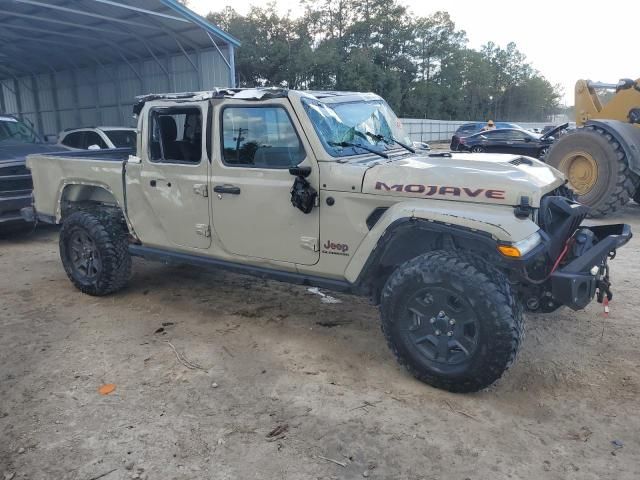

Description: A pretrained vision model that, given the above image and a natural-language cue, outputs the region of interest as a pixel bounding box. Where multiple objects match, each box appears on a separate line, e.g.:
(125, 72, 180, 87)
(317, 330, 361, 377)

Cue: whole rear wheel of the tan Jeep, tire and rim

(59, 209, 131, 296)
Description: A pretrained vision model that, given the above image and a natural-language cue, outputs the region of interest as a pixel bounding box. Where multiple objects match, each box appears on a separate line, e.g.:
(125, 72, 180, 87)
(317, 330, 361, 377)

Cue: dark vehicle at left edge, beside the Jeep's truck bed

(0, 114, 66, 229)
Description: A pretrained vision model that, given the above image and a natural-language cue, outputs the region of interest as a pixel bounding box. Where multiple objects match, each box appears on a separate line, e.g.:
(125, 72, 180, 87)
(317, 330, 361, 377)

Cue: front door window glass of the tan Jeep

(222, 107, 305, 168)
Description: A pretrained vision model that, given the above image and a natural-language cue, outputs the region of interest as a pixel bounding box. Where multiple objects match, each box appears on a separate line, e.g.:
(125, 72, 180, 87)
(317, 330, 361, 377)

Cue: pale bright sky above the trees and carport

(188, 0, 640, 105)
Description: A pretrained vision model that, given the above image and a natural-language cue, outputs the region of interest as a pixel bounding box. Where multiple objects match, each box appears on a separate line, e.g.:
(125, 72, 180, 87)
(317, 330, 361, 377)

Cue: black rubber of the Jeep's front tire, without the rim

(380, 250, 524, 393)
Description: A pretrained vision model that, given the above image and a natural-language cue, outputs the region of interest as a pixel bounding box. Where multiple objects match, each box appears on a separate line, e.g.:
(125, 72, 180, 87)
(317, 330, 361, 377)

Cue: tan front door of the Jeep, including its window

(211, 99, 320, 265)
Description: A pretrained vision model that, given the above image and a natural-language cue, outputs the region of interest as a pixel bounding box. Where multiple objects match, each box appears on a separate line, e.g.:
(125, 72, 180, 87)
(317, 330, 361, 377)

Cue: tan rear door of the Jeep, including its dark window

(127, 104, 211, 249)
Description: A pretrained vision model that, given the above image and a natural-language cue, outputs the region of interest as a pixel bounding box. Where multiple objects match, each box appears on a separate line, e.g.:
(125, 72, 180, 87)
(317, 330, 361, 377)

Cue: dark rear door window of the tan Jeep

(149, 107, 202, 164)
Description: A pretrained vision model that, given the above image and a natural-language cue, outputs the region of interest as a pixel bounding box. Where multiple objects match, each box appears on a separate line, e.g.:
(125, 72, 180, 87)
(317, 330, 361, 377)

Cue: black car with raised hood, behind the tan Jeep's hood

(457, 123, 569, 159)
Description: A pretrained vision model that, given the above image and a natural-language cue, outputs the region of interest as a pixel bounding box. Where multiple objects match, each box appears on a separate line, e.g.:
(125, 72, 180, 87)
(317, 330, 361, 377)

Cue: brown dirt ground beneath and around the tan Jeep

(0, 205, 640, 480)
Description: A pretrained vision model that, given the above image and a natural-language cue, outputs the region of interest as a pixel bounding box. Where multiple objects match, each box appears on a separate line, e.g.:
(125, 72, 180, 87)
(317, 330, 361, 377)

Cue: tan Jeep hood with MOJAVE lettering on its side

(362, 153, 565, 207)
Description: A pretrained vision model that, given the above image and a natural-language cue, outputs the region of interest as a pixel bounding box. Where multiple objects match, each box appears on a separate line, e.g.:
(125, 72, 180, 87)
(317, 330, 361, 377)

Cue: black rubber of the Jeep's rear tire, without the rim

(59, 208, 131, 296)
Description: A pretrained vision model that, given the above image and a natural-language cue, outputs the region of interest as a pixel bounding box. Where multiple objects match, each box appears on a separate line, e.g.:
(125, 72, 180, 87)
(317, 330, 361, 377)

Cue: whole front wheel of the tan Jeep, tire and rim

(380, 250, 524, 392)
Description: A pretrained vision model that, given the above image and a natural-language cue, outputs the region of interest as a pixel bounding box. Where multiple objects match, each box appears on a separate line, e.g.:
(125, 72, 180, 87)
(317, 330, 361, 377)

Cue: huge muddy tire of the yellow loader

(545, 125, 637, 217)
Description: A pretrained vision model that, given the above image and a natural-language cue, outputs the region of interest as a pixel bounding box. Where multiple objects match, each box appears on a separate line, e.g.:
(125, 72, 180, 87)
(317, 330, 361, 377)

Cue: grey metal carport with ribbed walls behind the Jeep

(0, 0, 240, 134)
